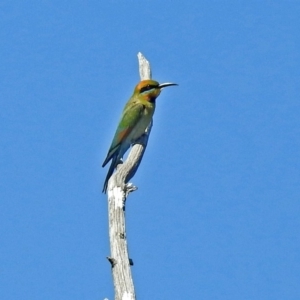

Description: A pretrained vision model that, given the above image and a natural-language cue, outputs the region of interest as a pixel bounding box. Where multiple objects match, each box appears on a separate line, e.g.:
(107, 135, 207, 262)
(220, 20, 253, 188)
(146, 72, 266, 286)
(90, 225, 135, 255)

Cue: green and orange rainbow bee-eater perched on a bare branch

(102, 80, 177, 193)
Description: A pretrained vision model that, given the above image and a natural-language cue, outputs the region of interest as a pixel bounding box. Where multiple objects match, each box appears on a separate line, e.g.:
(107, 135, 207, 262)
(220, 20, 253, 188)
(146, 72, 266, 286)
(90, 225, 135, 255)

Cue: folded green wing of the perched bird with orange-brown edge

(102, 102, 145, 167)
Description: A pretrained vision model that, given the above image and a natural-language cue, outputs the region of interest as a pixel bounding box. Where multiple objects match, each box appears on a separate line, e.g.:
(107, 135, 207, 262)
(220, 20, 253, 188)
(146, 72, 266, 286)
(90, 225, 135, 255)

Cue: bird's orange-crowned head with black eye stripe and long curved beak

(134, 79, 178, 102)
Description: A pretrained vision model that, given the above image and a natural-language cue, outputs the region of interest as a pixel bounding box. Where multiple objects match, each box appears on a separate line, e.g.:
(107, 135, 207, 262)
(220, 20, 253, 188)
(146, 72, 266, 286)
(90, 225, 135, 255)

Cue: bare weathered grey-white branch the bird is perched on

(107, 53, 152, 300)
